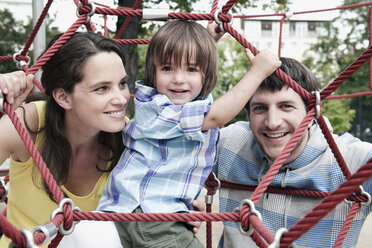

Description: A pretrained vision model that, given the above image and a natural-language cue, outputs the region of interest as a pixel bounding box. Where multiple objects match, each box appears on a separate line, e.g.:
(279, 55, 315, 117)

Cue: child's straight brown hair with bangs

(144, 20, 217, 97)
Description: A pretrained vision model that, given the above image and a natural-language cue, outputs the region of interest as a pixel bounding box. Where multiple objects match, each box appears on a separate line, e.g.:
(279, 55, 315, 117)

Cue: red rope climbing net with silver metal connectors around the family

(0, 0, 372, 247)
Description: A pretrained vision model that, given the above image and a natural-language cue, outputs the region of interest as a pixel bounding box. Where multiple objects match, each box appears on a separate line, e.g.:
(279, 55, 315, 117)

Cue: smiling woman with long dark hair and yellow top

(0, 32, 130, 247)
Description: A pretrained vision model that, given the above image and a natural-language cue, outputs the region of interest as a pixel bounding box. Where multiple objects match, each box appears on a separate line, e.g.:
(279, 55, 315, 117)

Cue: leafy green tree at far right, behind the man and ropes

(304, 0, 372, 141)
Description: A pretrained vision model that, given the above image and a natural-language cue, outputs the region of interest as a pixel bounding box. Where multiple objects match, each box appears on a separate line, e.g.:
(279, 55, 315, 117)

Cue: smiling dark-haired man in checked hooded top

(215, 58, 372, 248)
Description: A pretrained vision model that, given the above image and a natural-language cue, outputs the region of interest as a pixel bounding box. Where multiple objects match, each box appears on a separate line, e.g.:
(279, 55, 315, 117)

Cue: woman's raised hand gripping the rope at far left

(0, 71, 34, 109)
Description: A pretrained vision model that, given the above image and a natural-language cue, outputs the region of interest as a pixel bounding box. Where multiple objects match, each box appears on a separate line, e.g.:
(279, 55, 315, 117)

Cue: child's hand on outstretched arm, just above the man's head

(245, 48, 282, 78)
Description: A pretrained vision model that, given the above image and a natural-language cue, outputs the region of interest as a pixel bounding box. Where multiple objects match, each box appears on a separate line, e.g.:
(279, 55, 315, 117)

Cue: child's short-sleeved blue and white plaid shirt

(98, 82, 219, 213)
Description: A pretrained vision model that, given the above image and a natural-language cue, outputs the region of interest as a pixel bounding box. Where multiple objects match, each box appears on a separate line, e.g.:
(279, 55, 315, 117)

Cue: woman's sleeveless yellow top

(0, 101, 109, 247)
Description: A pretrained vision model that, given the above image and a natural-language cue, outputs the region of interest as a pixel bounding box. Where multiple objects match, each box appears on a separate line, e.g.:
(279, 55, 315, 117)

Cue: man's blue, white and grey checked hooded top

(215, 122, 372, 248)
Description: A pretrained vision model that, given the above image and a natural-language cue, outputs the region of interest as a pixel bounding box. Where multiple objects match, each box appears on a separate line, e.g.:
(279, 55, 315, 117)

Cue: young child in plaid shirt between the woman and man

(98, 20, 281, 247)
